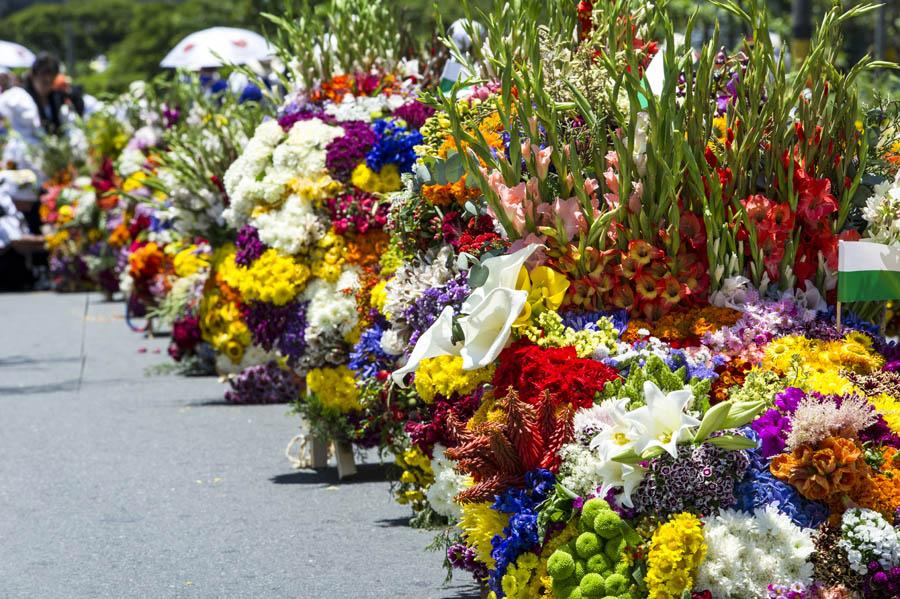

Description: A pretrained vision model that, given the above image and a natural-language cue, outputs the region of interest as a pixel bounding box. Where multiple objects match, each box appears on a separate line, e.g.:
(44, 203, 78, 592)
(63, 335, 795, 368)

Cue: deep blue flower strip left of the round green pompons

(488, 468, 556, 597)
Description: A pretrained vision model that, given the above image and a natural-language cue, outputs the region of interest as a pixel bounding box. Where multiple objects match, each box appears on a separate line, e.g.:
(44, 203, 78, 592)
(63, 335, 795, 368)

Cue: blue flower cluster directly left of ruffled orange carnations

(735, 426, 828, 528)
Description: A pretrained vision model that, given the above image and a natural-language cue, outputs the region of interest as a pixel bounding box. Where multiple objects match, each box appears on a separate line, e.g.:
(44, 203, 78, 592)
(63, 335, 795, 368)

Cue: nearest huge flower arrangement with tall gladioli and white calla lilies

(328, 2, 900, 598)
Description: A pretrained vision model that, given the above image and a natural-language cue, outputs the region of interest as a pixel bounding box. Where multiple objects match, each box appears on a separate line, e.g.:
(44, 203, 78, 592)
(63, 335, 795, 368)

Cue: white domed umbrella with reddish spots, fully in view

(159, 27, 272, 71)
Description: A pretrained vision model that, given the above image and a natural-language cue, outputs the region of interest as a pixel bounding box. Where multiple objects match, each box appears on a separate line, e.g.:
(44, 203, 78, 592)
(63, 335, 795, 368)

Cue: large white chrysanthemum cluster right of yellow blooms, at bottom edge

(694, 506, 814, 599)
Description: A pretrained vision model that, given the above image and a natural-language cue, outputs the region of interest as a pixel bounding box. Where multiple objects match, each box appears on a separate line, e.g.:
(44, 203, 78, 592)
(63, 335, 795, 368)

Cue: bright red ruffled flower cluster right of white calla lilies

(493, 340, 619, 408)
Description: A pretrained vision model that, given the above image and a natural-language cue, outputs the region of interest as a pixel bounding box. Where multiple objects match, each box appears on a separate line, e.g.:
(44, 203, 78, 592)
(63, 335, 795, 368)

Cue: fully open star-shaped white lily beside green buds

(628, 381, 700, 458)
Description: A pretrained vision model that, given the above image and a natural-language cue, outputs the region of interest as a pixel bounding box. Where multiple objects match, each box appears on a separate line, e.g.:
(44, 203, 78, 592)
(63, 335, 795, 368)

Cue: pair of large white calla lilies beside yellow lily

(391, 244, 540, 386)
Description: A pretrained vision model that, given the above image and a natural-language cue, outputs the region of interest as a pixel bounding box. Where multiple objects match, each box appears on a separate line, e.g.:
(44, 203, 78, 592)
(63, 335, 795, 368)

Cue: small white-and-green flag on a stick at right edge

(837, 241, 900, 302)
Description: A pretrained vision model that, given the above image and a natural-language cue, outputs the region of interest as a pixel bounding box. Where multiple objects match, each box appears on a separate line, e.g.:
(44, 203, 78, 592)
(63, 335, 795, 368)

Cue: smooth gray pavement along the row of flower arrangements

(0, 293, 477, 599)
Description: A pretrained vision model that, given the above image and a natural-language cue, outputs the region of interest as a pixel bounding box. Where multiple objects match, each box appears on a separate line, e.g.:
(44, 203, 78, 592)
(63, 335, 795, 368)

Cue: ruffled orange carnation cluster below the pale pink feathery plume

(769, 437, 870, 513)
